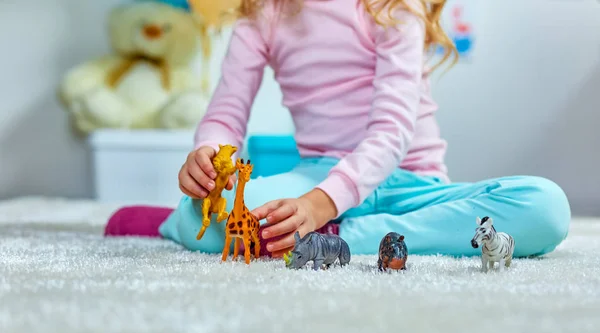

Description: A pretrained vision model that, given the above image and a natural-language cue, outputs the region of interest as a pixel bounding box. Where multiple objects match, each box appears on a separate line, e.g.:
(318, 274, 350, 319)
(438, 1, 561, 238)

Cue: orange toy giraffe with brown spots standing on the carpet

(222, 159, 260, 264)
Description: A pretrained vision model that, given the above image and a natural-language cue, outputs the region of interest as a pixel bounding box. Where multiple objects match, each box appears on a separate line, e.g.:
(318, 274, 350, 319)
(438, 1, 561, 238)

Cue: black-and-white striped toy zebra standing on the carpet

(471, 216, 515, 272)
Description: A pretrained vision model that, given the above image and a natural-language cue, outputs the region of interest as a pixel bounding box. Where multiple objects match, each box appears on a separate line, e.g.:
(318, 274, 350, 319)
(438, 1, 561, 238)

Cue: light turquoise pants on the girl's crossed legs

(159, 158, 571, 257)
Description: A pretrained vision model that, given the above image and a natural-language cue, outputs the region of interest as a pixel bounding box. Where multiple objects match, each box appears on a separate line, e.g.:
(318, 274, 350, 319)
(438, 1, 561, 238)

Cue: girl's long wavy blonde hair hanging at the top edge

(238, 0, 458, 70)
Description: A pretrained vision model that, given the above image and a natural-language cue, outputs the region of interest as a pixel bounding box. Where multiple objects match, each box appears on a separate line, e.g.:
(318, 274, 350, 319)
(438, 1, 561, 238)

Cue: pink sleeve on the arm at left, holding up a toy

(194, 19, 267, 151)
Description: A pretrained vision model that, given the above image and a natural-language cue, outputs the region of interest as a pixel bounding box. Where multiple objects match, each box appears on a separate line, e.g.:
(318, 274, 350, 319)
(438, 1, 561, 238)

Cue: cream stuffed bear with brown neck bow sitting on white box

(60, 2, 208, 133)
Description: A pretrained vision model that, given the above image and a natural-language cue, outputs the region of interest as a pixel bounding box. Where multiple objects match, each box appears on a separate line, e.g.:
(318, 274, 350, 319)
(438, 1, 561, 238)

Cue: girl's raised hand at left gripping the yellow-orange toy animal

(179, 146, 235, 199)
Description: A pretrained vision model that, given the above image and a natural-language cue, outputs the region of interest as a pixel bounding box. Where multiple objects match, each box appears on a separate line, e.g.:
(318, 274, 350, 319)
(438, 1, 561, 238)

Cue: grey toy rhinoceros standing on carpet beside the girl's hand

(283, 231, 350, 271)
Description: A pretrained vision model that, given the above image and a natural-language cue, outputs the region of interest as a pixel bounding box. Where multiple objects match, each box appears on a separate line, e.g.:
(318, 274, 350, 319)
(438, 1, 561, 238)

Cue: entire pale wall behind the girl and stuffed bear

(0, 0, 600, 215)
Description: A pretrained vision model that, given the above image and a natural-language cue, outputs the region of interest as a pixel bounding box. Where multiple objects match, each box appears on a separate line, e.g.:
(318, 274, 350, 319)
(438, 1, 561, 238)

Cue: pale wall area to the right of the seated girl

(434, 0, 600, 215)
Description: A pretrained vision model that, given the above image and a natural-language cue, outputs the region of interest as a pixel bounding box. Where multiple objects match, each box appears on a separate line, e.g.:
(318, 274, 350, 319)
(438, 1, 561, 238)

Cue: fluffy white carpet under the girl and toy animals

(0, 198, 600, 333)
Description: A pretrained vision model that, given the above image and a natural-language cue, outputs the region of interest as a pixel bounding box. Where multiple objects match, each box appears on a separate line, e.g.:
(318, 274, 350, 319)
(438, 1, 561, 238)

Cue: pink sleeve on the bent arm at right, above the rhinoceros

(318, 11, 425, 217)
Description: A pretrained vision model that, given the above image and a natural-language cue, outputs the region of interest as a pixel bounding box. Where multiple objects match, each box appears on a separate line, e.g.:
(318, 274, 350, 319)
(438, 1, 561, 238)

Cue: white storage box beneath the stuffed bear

(89, 130, 194, 207)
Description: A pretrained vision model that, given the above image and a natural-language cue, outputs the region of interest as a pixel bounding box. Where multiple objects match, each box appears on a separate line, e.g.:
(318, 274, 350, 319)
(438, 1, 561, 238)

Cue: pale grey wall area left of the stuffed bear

(0, 0, 117, 198)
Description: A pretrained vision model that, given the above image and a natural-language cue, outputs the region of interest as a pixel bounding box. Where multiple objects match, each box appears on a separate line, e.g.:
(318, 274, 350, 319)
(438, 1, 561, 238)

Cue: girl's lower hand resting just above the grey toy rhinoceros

(252, 189, 337, 257)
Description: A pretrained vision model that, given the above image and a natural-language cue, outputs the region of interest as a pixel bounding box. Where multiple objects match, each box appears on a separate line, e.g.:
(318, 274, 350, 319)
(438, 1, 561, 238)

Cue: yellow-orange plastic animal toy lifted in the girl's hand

(196, 145, 237, 240)
